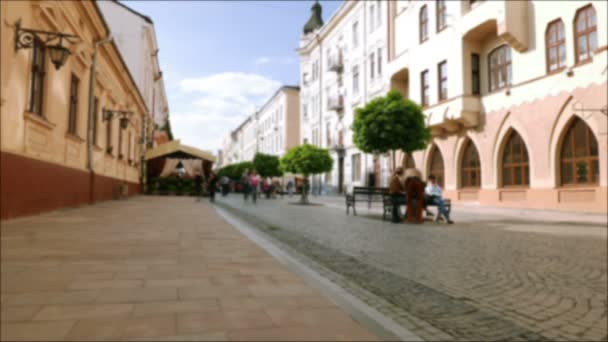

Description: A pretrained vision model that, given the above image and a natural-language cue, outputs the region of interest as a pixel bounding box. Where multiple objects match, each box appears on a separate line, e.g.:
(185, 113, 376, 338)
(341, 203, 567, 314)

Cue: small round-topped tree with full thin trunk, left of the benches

(281, 144, 333, 204)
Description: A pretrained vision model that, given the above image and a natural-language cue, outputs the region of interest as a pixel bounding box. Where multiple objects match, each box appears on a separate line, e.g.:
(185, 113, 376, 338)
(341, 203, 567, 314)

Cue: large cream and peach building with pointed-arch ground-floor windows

(387, 1, 608, 213)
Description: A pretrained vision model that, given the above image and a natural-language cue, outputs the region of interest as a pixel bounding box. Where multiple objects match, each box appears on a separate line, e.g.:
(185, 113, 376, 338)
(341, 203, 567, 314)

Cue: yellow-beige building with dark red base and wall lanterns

(0, 1, 149, 219)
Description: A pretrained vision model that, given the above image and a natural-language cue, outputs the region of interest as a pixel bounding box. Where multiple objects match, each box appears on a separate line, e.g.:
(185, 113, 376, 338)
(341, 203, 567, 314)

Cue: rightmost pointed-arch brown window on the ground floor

(559, 118, 600, 185)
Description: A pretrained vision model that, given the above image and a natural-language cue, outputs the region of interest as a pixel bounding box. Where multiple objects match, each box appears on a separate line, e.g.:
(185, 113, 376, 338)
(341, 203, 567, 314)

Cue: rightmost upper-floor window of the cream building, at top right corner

(574, 5, 597, 63)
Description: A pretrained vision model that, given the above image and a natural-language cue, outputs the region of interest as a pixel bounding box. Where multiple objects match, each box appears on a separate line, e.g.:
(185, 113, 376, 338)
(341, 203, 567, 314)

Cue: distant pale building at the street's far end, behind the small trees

(222, 86, 300, 166)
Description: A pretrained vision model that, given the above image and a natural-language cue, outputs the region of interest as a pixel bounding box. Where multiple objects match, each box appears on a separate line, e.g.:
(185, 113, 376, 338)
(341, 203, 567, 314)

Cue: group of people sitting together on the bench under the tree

(389, 167, 454, 224)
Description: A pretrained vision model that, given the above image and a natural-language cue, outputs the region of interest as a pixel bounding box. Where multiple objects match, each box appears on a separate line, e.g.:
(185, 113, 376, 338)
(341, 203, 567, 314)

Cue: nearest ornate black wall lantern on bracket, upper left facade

(15, 19, 80, 70)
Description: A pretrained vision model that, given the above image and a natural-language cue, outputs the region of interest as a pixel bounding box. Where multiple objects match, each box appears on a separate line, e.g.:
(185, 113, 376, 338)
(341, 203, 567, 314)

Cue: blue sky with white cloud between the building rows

(123, 0, 342, 153)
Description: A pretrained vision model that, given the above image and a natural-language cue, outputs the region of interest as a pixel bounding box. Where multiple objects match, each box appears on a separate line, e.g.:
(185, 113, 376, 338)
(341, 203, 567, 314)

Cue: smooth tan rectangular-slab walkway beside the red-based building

(0, 197, 376, 341)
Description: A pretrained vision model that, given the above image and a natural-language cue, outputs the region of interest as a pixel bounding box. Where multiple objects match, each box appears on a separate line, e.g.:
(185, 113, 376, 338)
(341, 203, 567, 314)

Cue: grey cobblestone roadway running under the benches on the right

(218, 196, 608, 341)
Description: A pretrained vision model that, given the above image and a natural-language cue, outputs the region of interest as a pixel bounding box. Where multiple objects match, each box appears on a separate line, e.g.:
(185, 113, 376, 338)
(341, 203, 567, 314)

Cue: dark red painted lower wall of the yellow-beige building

(0, 152, 141, 220)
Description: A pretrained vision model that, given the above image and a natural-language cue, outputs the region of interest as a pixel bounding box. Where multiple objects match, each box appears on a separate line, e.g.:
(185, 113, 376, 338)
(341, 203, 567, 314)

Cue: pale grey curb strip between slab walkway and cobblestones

(214, 206, 423, 341)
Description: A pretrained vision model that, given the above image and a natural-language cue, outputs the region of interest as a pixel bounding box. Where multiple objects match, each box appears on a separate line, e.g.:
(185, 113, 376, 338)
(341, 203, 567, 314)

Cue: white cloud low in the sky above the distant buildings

(170, 72, 281, 153)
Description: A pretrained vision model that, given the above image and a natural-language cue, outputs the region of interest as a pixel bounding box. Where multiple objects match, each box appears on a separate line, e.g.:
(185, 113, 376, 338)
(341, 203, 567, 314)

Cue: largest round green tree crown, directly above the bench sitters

(351, 90, 431, 170)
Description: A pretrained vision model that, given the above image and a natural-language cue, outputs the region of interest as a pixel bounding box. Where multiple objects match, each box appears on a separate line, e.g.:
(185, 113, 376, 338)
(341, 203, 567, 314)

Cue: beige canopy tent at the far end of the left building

(144, 140, 216, 179)
